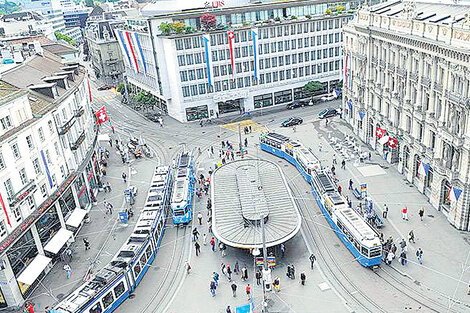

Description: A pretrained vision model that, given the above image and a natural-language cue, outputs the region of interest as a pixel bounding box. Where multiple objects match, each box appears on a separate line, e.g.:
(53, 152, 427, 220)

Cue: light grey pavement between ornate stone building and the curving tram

(279, 119, 470, 303)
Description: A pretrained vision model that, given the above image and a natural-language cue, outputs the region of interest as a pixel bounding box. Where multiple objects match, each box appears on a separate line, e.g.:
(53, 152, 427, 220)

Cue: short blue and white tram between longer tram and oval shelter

(171, 152, 196, 225)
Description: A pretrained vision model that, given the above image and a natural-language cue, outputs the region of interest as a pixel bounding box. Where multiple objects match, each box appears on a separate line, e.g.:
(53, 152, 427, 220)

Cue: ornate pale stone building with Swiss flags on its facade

(343, 1, 470, 230)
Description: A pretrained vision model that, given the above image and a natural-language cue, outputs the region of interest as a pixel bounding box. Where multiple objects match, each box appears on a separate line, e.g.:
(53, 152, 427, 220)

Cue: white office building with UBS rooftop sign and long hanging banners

(117, 0, 352, 121)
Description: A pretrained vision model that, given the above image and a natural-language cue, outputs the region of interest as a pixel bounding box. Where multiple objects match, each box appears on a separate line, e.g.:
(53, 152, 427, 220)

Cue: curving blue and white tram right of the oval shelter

(260, 133, 382, 267)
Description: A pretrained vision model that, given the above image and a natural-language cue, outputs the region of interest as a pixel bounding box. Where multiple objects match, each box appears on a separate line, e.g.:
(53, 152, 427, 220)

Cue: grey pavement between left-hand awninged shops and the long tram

(28, 134, 158, 312)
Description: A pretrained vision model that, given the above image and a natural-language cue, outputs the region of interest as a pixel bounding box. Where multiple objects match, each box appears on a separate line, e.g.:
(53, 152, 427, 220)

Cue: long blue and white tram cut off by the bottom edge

(54, 166, 171, 313)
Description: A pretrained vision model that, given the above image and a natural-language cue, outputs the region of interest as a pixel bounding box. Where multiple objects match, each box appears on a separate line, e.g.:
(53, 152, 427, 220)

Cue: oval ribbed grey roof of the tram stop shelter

(211, 159, 301, 249)
